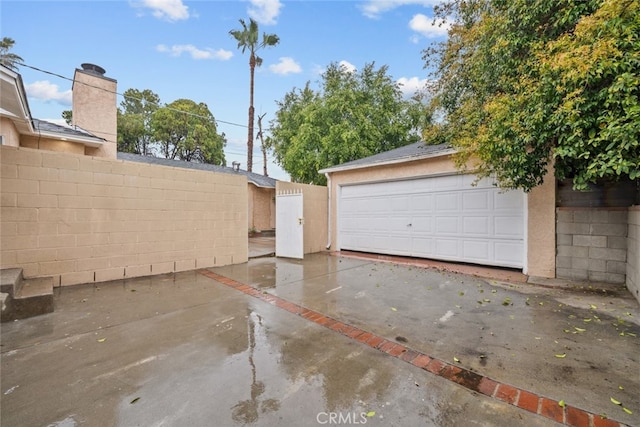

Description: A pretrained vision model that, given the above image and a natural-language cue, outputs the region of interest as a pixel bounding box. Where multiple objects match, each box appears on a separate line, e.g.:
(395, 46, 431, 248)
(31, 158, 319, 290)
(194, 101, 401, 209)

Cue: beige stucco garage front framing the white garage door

(329, 155, 555, 277)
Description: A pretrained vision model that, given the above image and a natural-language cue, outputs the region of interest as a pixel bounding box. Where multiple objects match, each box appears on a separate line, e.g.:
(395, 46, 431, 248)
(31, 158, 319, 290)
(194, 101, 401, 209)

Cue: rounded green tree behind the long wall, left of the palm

(150, 99, 226, 166)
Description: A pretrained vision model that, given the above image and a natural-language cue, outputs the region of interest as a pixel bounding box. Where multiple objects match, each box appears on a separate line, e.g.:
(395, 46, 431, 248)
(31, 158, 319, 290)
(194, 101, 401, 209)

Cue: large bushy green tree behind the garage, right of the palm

(267, 63, 426, 184)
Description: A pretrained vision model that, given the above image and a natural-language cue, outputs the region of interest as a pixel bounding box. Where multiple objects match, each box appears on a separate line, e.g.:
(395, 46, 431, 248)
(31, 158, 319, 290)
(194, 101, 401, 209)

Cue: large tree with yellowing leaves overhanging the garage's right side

(424, 0, 640, 191)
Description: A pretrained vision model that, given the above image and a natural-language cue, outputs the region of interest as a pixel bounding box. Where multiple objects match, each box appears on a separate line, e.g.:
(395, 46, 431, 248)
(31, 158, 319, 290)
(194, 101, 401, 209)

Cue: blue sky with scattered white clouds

(0, 0, 446, 180)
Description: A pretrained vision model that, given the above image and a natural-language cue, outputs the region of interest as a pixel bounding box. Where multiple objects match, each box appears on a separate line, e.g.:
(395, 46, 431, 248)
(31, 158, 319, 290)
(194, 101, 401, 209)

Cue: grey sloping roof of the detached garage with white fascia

(318, 141, 455, 173)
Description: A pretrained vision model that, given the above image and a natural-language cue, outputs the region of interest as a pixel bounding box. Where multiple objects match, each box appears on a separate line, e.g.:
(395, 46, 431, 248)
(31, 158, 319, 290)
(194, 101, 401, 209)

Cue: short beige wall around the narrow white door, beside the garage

(276, 181, 328, 254)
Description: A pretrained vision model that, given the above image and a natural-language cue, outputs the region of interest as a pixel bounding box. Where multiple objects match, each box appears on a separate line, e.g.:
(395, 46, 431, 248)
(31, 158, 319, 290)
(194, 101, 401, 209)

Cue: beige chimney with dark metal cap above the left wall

(71, 64, 118, 159)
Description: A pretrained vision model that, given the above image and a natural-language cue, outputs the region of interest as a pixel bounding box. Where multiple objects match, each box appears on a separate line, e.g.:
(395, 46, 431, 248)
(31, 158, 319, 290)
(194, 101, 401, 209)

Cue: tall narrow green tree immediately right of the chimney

(118, 89, 160, 156)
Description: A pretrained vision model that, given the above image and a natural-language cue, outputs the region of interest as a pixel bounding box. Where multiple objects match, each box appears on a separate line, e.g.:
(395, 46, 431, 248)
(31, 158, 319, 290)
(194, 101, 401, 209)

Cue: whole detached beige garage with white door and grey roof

(320, 143, 555, 277)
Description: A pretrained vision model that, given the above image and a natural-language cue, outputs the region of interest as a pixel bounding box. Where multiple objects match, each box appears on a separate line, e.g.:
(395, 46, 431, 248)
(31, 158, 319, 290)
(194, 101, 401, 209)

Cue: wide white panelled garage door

(338, 175, 525, 268)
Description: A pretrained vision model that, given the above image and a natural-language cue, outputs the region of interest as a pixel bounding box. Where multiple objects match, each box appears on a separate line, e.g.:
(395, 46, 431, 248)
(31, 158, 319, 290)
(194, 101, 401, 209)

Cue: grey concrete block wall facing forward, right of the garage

(556, 207, 628, 283)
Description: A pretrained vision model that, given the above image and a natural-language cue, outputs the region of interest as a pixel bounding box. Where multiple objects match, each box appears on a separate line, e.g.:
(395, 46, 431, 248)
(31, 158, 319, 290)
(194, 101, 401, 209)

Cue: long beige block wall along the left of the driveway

(0, 147, 248, 285)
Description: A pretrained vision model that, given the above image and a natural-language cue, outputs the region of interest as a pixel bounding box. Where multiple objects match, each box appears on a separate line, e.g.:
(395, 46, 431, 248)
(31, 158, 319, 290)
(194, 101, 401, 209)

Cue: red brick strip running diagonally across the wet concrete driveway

(198, 270, 625, 427)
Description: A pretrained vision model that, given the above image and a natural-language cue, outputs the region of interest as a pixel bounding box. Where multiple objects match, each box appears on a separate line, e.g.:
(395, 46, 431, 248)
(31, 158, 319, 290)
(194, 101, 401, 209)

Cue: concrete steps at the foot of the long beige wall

(0, 269, 53, 322)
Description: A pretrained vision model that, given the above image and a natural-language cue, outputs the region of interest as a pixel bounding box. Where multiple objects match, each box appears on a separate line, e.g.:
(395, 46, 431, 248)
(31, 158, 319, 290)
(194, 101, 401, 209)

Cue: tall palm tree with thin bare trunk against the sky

(229, 19, 280, 172)
